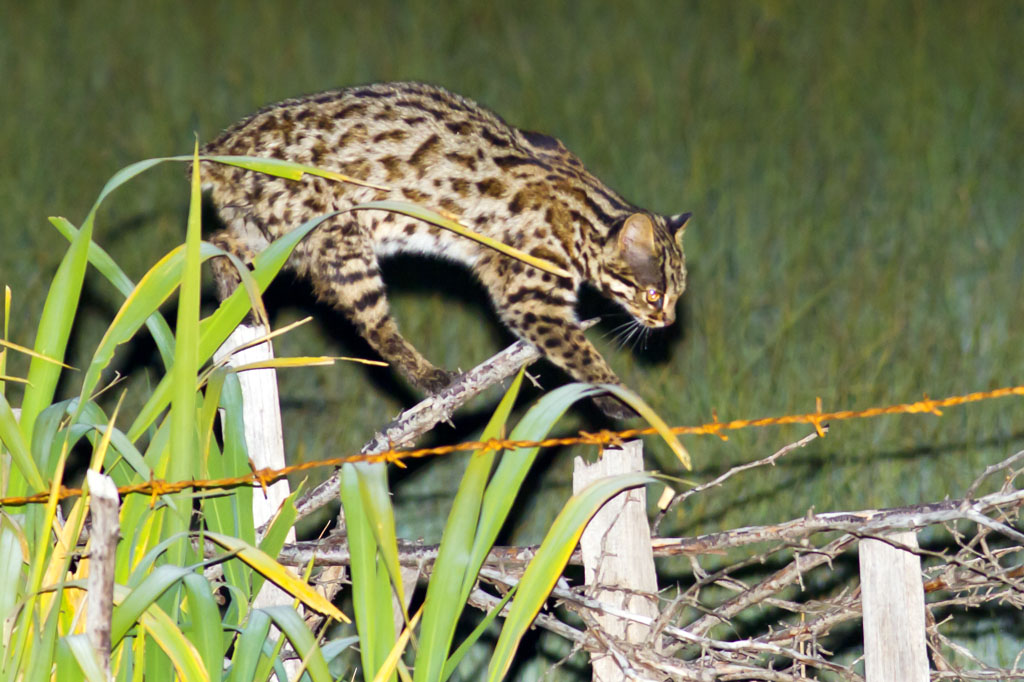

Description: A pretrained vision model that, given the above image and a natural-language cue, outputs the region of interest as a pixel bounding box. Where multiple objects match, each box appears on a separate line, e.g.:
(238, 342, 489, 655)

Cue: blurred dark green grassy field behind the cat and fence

(0, 0, 1024, 667)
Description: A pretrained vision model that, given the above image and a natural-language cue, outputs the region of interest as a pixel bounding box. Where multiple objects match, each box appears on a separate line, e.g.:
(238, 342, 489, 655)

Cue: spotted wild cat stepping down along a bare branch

(202, 83, 689, 417)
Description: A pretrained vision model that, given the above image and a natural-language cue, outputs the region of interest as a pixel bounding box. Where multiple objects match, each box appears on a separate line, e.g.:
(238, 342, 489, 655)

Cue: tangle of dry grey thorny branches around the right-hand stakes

(281, 440, 1024, 682)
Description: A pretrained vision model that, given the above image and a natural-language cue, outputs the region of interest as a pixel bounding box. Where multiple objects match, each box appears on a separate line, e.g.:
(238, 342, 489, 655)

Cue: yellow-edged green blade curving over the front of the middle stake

(487, 473, 655, 682)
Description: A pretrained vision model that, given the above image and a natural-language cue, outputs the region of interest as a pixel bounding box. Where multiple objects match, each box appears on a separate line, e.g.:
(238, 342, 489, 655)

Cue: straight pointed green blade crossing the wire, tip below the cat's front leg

(413, 371, 523, 681)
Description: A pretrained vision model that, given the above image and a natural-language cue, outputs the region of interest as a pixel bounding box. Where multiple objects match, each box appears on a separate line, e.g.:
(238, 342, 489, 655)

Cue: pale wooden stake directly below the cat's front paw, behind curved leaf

(572, 440, 658, 682)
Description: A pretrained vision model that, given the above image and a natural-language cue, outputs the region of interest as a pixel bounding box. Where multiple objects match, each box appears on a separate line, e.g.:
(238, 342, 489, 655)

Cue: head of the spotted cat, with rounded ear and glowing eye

(600, 212, 690, 327)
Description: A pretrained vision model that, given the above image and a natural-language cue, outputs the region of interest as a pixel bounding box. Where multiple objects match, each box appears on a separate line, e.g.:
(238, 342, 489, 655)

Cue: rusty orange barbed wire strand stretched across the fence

(0, 385, 1024, 507)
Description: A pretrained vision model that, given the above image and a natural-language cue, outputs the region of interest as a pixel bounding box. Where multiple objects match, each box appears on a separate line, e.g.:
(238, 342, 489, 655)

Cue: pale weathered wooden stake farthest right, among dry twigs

(860, 531, 929, 682)
